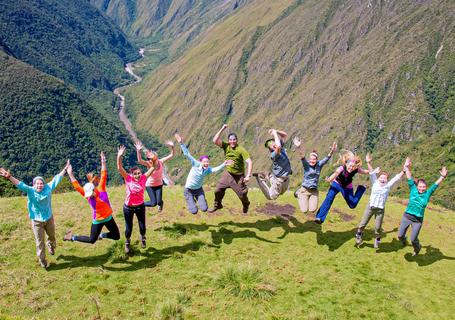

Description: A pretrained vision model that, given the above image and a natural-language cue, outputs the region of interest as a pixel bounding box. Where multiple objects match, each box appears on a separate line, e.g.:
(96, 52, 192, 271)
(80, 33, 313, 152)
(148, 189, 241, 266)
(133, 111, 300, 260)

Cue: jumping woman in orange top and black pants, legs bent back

(63, 152, 120, 244)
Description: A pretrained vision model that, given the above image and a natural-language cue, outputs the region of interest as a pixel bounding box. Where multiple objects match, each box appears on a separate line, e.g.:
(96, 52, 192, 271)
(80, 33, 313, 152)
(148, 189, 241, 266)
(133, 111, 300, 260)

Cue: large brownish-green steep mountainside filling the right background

(128, 0, 455, 208)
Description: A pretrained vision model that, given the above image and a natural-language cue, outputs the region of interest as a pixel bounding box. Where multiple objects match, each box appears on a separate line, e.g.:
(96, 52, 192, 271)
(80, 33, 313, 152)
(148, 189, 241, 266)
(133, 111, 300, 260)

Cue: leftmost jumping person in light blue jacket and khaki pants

(0, 161, 69, 268)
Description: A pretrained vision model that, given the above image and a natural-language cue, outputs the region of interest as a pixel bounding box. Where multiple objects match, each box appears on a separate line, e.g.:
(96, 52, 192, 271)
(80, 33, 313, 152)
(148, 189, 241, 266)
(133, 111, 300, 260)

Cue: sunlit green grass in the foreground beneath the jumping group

(0, 185, 455, 319)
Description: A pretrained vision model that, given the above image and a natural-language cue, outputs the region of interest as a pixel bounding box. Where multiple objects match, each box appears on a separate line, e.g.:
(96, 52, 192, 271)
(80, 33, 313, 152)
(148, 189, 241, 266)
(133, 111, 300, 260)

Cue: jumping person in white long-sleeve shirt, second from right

(355, 153, 404, 249)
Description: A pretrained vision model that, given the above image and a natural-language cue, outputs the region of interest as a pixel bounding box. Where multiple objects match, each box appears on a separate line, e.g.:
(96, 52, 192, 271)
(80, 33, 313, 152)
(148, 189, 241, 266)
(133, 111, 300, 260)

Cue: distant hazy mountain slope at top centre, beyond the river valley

(90, 0, 251, 55)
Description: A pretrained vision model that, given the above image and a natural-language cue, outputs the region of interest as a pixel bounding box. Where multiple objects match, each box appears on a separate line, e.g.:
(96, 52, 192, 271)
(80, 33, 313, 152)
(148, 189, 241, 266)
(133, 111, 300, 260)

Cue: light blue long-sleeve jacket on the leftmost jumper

(17, 174, 63, 222)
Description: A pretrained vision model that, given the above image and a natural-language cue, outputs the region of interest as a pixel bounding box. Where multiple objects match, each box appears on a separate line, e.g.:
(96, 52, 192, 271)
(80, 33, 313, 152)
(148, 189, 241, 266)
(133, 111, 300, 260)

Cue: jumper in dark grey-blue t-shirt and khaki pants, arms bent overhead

(253, 129, 292, 200)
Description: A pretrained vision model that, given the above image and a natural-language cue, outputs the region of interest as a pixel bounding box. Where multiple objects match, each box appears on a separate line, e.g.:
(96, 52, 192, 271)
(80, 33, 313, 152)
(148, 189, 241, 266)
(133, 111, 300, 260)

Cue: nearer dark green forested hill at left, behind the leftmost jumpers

(0, 51, 141, 196)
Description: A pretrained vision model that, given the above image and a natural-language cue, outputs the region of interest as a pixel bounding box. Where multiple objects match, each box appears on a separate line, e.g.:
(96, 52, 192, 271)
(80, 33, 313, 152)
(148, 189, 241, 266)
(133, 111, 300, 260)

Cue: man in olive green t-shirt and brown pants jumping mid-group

(208, 124, 253, 213)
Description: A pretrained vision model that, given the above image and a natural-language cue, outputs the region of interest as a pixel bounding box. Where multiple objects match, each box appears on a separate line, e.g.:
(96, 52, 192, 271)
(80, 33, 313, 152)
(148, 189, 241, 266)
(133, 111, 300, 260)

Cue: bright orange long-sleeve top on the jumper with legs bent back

(72, 170, 112, 224)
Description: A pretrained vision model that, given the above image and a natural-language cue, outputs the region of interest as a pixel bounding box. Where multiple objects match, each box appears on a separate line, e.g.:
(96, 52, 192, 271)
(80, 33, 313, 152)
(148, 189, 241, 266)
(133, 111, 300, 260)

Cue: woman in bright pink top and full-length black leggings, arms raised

(117, 146, 155, 253)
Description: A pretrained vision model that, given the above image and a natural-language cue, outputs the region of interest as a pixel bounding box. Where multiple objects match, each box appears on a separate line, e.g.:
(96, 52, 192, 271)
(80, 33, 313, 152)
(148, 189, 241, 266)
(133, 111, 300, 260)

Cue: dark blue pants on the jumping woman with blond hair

(316, 182, 366, 222)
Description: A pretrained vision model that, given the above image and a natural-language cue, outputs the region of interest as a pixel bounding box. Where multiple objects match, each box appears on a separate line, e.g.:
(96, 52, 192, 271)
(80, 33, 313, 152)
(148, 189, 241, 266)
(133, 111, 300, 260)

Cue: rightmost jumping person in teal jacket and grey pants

(398, 158, 447, 256)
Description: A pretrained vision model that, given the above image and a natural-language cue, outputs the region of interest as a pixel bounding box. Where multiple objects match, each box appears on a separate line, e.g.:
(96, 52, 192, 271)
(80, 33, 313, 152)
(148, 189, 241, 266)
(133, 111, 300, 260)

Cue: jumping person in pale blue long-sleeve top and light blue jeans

(175, 133, 234, 214)
